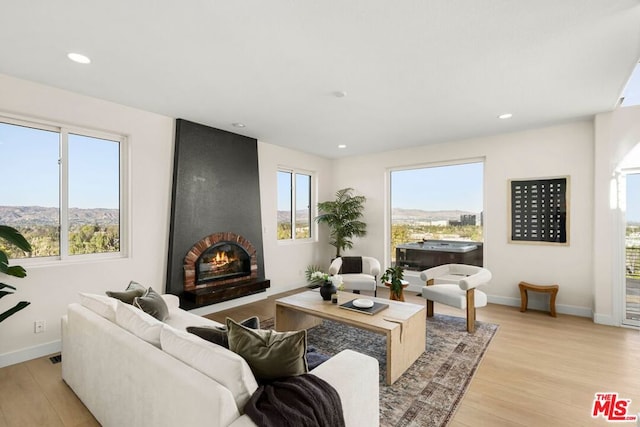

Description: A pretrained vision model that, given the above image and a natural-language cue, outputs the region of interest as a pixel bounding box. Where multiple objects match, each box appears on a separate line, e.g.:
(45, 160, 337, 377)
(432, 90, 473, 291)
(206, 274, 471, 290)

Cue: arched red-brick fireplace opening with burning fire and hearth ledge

(184, 232, 269, 305)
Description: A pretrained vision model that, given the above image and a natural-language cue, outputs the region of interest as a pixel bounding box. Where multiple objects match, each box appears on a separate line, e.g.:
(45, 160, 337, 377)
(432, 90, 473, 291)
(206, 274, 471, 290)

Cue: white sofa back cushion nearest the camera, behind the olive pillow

(160, 325, 258, 412)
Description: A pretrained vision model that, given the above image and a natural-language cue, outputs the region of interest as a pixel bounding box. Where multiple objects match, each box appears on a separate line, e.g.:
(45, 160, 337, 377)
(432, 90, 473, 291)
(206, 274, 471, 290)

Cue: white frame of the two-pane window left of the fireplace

(0, 112, 131, 267)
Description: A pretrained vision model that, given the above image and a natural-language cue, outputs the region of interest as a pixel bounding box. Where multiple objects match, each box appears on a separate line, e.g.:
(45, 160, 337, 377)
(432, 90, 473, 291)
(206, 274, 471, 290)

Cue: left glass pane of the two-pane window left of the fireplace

(0, 123, 60, 258)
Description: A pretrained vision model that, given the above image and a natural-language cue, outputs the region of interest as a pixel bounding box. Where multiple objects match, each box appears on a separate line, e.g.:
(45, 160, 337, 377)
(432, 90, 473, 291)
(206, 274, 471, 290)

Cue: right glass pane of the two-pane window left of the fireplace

(68, 134, 120, 255)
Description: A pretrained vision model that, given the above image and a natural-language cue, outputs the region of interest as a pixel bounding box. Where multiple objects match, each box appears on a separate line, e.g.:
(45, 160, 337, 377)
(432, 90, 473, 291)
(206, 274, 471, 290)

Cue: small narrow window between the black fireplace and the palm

(278, 170, 311, 240)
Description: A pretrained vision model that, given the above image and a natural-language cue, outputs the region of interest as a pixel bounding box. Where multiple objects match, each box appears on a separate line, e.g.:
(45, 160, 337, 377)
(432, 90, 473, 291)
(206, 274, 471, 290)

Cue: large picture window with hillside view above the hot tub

(390, 161, 483, 265)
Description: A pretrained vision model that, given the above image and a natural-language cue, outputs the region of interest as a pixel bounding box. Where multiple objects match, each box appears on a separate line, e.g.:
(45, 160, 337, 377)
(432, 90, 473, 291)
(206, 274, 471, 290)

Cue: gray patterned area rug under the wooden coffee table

(262, 314, 498, 427)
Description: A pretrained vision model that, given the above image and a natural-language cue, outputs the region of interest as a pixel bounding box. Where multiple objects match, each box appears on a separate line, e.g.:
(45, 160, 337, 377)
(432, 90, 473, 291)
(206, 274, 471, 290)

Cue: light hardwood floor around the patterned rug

(0, 288, 640, 427)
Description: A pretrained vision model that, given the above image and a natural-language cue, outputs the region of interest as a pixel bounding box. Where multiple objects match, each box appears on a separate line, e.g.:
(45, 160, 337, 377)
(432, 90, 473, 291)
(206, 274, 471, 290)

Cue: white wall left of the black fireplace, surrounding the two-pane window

(0, 75, 174, 366)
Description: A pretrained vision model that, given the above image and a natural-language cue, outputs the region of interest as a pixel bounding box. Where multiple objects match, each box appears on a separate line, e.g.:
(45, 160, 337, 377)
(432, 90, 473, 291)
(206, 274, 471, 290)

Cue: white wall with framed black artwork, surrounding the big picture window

(334, 121, 594, 316)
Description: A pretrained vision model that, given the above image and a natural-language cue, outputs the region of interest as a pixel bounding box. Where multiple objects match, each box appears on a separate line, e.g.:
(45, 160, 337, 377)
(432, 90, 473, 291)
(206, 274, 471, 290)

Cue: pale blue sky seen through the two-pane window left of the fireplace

(0, 123, 120, 209)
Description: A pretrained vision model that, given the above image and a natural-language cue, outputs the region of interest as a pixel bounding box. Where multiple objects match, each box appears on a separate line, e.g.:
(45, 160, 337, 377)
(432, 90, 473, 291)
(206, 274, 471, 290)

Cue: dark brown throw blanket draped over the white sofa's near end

(244, 374, 345, 427)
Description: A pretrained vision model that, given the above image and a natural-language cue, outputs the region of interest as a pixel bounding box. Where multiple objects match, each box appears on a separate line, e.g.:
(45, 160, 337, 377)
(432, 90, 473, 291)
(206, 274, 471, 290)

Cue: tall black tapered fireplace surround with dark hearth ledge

(166, 119, 269, 309)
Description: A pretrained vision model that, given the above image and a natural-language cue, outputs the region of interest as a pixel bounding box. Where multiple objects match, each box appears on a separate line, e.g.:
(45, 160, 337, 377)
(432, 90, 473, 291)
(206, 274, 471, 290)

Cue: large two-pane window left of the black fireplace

(0, 118, 124, 258)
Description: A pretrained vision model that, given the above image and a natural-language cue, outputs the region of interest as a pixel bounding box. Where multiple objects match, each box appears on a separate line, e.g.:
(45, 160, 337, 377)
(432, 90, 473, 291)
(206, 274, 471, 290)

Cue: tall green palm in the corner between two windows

(316, 188, 367, 258)
